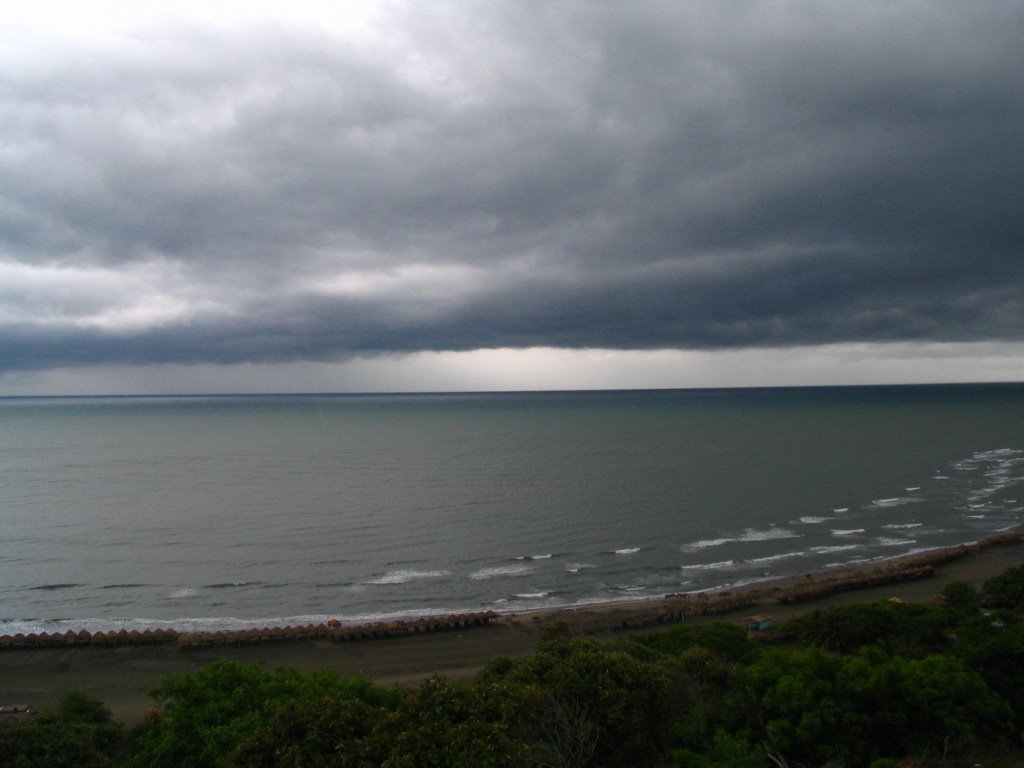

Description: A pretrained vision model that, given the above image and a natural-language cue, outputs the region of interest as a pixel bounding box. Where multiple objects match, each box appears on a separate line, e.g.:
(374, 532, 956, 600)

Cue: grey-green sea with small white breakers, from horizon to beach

(0, 384, 1024, 634)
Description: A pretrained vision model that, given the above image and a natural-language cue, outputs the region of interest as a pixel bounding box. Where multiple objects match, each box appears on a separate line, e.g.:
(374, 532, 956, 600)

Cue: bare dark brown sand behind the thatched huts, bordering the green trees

(0, 539, 1024, 724)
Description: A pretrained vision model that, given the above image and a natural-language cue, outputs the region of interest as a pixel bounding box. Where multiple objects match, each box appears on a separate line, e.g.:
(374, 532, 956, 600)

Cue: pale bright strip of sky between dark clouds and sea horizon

(0, 342, 1024, 396)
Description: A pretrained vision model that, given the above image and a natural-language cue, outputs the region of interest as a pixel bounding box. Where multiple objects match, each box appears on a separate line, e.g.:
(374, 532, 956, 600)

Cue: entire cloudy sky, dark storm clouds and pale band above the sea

(0, 0, 1024, 395)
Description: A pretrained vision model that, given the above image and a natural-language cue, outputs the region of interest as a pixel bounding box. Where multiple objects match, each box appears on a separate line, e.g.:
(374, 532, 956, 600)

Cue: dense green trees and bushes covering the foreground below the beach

(6, 567, 1024, 768)
